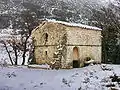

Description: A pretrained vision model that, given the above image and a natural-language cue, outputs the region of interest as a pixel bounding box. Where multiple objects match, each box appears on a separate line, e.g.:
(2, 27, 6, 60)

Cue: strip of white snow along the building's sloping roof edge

(46, 19, 102, 30)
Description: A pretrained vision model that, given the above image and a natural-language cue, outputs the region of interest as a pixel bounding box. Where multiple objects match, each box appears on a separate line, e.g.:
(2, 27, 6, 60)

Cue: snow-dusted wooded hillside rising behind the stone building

(0, 0, 111, 29)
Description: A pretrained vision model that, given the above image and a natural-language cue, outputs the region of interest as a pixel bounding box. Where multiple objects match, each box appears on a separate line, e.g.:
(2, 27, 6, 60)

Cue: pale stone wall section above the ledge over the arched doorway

(66, 27, 101, 45)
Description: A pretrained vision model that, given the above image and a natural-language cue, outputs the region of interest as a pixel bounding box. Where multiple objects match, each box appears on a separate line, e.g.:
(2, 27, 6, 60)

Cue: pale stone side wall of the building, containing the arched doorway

(66, 27, 102, 65)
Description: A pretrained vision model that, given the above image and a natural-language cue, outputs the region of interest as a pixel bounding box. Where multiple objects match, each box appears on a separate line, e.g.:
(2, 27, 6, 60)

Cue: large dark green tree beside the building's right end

(92, 1, 120, 64)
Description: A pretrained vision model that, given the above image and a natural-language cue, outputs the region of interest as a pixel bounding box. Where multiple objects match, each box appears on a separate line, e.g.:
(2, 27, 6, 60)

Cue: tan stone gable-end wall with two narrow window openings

(32, 22, 66, 64)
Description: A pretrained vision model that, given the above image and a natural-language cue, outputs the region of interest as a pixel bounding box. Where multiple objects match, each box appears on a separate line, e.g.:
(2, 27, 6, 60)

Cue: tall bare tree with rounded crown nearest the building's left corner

(12, 10, 38, 65)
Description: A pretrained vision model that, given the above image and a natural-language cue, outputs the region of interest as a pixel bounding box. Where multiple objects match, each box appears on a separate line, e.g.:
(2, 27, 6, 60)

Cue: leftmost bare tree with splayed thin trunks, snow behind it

(0, 36, 21, 65)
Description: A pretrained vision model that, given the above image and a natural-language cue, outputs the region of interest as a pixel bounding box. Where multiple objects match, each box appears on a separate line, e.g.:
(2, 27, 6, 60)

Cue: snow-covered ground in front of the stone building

(0, 65, 120, 90)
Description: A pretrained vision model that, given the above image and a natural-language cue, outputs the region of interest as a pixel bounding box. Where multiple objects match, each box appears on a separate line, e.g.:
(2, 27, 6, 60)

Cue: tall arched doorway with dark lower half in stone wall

(73, 47, 79, 68)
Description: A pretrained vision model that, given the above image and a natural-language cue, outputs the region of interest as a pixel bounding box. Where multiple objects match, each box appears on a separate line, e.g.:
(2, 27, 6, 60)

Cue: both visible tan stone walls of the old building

(32, 22, 101, 68)
